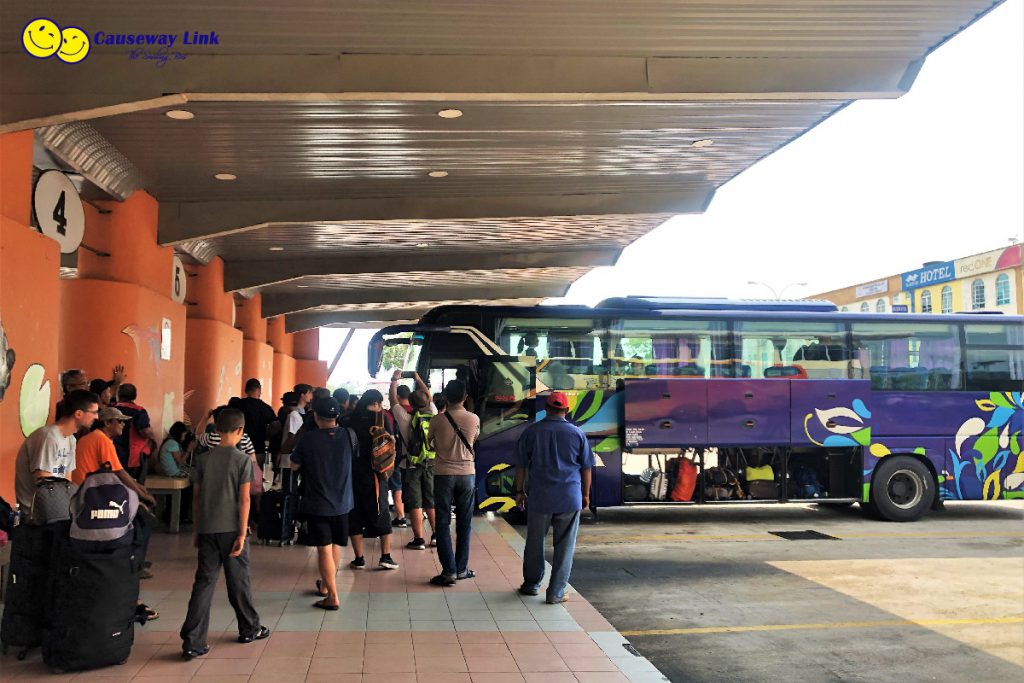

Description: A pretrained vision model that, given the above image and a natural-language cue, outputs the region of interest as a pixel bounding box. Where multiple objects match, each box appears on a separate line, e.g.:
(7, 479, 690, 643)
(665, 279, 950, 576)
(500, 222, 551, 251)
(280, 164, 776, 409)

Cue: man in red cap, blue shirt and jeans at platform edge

(513, 391, 594, 604)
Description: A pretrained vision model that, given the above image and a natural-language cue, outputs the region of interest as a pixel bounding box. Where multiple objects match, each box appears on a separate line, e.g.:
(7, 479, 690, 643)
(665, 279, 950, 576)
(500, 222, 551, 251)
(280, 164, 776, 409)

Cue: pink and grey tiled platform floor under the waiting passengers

(0, 517, 666, 683)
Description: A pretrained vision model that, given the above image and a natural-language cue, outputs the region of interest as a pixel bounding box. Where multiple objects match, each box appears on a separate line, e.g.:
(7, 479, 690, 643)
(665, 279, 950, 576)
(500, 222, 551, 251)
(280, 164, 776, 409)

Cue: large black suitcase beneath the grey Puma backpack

(43, 538, 141, 673)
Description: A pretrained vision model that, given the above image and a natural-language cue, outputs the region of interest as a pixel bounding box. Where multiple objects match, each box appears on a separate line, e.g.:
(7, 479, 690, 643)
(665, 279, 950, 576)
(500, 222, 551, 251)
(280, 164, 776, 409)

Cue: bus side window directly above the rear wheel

(853, 323, 961, 391)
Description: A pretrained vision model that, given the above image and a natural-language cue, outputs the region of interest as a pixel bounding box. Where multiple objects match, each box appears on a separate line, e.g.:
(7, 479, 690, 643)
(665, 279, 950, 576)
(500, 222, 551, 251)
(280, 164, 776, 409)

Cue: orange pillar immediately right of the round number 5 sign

(184, 258, 243, 424)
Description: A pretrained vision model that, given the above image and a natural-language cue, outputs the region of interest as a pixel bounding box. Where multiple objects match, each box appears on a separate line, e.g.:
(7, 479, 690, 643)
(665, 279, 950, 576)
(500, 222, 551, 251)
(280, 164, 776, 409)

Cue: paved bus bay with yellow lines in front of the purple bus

(572, 502, 1024, 683)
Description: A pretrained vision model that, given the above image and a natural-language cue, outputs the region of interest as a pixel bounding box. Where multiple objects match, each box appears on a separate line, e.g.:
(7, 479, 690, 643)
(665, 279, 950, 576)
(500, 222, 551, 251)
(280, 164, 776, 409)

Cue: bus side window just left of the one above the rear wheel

(735, 321, 847, 379)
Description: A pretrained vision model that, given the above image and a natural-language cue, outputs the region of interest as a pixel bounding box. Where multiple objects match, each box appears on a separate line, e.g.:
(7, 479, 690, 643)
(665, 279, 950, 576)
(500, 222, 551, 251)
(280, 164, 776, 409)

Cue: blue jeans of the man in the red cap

(522, 506, 581, 601)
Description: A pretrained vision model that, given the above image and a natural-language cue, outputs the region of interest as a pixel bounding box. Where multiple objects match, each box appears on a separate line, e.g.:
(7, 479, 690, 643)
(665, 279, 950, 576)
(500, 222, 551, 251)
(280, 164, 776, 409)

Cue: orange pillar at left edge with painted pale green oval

(0, 130, 60, 503)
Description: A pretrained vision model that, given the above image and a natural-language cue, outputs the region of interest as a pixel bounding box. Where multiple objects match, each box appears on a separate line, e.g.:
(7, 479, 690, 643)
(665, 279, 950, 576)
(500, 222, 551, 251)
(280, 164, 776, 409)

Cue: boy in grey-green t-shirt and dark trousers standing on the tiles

(180, 408, 270, 659)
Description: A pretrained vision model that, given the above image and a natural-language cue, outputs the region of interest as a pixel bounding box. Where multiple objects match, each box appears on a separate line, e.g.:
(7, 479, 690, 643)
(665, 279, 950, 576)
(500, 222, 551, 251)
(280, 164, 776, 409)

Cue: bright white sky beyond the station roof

(321, 0, 1024, 389)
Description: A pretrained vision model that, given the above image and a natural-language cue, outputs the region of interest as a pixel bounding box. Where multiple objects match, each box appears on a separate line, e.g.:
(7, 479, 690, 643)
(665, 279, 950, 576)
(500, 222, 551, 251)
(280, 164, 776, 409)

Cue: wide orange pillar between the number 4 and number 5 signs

(59, 191, 185, 436)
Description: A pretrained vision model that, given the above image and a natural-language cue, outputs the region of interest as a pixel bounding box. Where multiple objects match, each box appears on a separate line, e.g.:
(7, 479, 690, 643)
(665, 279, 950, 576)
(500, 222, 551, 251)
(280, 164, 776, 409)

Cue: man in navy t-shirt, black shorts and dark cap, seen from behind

(292, 398, 358, 611)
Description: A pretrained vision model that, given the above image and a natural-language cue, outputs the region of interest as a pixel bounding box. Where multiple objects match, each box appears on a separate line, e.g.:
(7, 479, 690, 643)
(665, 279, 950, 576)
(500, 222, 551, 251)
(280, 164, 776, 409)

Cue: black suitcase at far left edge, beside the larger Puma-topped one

(0, 524, 56, 659)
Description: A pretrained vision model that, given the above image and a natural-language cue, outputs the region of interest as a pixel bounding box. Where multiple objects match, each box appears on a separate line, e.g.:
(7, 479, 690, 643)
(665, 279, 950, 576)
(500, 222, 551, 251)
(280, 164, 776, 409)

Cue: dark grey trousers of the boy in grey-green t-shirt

(179, 531, 260, 650)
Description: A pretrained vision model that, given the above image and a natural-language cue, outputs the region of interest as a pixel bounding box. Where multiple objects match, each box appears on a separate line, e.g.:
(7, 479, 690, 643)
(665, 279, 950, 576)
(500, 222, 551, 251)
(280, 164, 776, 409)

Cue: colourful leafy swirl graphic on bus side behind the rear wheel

(945, 391, 1024, 501)
